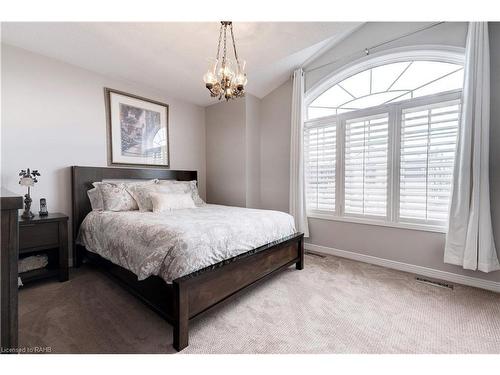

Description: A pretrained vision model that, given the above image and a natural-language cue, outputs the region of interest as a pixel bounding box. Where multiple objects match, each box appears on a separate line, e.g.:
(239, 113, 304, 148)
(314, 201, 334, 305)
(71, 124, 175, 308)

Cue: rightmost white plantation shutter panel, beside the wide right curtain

(399, 100, 460, 224)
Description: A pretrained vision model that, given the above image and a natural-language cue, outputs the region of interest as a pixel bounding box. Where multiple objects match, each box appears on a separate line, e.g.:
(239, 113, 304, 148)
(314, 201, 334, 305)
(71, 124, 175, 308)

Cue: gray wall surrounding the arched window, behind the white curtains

(261, 23, 500, 281)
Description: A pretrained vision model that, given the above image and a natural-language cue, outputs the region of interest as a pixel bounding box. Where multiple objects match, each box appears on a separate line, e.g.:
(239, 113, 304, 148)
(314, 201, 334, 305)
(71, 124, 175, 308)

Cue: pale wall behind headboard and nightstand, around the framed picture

(1, 45, 205, 247)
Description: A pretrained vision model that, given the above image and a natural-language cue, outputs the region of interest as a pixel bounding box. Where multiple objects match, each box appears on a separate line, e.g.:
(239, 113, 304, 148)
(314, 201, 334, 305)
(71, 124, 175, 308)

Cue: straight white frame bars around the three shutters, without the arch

(304, 89, 462, 233)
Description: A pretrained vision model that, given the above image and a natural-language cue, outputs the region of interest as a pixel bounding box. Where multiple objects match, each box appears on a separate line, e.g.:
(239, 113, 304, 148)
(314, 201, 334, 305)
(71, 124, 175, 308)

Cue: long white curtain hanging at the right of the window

(444, 22, 500, 272)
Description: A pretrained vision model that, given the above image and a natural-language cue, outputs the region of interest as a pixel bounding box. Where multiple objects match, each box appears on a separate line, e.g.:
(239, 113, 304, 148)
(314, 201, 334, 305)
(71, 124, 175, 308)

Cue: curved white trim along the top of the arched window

(304, 45, 465, 108)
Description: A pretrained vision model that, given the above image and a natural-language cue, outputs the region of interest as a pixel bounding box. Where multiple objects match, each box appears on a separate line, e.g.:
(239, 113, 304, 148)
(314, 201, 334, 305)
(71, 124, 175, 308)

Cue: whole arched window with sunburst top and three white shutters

(304, 50, 464, 230)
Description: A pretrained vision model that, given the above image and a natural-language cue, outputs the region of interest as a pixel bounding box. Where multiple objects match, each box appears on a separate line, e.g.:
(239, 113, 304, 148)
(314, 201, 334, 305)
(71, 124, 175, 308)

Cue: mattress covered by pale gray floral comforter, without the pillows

(77, 204, 295, 283)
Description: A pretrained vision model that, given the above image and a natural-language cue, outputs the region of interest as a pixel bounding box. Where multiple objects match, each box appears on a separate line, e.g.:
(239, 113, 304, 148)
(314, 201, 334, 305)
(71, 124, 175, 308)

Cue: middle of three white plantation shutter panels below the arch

(344, 114, 389, 216)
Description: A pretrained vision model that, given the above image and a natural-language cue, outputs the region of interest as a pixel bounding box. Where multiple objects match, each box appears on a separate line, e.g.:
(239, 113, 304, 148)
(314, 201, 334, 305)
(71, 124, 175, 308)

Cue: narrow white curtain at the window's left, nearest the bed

(290, 68, 309, 237)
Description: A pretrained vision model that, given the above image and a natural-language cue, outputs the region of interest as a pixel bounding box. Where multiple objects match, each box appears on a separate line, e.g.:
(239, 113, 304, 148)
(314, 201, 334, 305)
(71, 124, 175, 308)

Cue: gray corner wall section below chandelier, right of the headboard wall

(205, 94, 260, 208)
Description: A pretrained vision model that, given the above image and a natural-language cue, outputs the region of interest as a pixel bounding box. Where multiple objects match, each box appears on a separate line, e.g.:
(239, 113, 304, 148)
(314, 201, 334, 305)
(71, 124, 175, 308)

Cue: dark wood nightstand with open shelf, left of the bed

(19, 212, 68, 284)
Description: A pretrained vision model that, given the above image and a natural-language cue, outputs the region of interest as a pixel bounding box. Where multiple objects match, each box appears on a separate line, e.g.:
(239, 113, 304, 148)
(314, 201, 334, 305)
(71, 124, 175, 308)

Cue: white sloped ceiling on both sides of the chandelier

(2, 22, 360, 106)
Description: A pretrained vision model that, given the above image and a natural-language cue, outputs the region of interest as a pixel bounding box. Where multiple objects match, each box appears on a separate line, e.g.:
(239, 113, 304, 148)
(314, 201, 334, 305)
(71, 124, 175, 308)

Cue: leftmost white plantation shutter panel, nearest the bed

(304, 124, 337, 212)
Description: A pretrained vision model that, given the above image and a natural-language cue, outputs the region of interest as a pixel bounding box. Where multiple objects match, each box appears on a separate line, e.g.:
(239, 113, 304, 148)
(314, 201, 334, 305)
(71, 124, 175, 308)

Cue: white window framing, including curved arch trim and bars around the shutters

(303, 44, 465, 233)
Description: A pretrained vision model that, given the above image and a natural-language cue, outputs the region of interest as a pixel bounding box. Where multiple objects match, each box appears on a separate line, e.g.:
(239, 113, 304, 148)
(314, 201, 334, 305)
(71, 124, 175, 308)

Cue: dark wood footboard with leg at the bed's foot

(173, 233, 304, 351)
